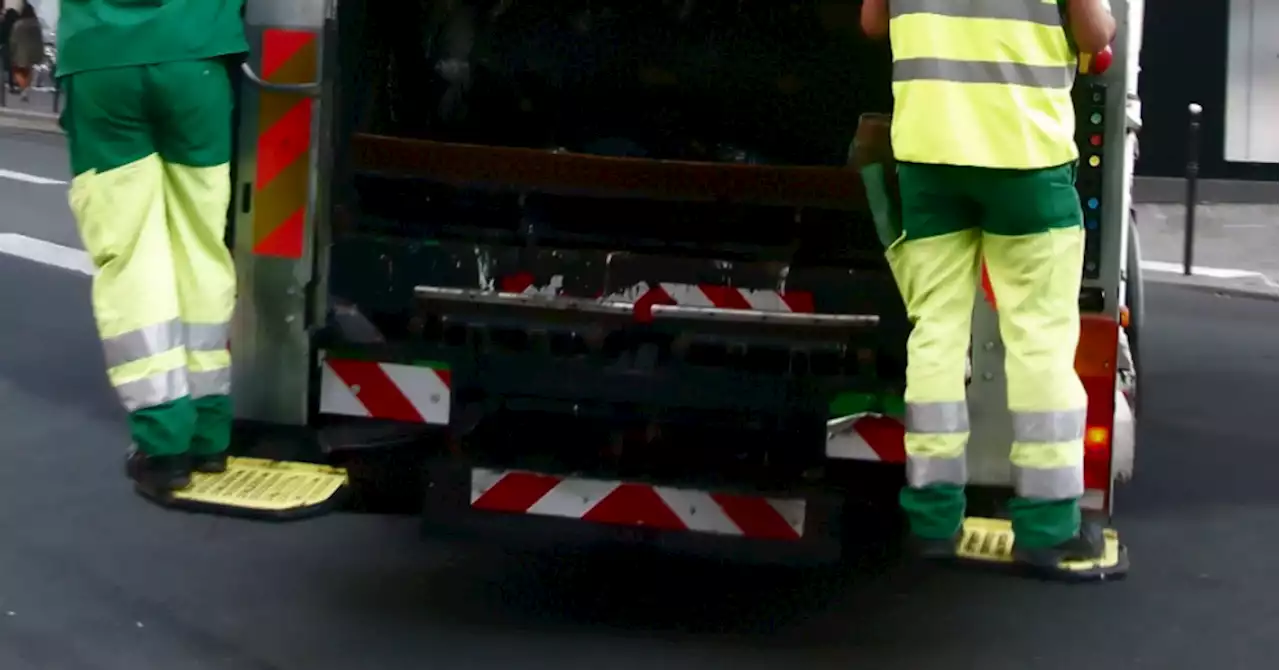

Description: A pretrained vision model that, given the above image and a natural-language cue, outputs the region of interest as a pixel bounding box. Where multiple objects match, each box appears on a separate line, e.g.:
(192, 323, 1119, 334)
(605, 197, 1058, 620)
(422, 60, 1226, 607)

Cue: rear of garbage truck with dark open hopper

(175, 0, 1142, 571)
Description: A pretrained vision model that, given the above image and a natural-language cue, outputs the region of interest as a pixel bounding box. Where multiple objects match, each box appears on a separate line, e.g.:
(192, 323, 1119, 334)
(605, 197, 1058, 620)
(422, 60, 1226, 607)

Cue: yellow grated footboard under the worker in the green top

(137, 457, 348, 521)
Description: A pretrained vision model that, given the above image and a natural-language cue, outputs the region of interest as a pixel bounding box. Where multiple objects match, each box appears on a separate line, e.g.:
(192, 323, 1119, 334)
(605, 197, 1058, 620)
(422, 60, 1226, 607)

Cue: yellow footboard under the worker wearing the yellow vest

(956, 516, 1129, 582)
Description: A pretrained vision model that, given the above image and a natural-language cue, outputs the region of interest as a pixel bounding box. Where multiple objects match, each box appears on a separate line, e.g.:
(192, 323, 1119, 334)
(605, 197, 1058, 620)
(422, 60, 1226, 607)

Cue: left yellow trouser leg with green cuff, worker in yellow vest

(886, 230, 978, 538)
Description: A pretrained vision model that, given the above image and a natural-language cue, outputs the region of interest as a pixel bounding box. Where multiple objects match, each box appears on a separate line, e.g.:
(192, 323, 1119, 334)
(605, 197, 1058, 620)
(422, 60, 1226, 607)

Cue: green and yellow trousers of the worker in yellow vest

(887, 163, 1087, 547)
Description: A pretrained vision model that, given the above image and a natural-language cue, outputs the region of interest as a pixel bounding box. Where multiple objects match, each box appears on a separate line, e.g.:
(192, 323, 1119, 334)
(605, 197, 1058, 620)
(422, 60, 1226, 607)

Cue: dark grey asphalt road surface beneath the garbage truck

(0, 131, 1280, 670)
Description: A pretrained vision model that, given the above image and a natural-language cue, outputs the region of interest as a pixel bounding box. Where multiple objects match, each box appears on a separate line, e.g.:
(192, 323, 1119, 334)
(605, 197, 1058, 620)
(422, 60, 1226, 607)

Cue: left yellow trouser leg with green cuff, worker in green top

(69, 153, 191, 453)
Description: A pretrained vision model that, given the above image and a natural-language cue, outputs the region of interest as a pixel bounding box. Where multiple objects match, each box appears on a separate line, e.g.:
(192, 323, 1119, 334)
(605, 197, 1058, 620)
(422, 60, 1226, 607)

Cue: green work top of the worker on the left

(58, 0, 248, 77)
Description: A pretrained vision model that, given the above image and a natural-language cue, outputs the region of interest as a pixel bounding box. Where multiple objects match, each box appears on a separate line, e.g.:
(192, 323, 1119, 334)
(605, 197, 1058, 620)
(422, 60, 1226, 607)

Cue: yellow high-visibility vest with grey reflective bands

(890, 0, 1079, 169)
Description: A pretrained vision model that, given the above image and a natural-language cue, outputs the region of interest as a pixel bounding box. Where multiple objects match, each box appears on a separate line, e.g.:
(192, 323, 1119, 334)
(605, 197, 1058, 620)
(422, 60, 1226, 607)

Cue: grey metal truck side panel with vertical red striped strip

(232, 0, 325, 427)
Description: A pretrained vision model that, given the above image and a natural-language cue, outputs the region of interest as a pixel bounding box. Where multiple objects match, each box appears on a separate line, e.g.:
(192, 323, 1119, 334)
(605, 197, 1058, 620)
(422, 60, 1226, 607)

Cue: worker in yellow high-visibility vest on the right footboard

(861, 0, 1115, 568)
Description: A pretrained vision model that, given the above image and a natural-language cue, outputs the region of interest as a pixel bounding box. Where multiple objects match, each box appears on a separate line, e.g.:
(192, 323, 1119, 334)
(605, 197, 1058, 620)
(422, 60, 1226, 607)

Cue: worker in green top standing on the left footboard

(58, 0, 248, 493)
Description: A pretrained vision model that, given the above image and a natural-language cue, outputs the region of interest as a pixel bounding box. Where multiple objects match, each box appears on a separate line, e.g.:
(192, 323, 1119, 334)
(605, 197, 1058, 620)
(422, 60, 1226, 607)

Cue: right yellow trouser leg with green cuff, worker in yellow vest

(983, 228, 1088, 546)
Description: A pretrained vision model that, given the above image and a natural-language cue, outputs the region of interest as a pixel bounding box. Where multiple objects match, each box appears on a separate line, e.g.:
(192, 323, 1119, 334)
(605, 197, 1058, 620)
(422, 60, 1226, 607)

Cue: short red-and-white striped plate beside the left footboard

(320, 357, 451, 425)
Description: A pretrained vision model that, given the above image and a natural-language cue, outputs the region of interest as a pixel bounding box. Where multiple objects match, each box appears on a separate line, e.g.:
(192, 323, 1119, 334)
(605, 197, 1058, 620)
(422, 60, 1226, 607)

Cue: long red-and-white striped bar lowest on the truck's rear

(471, 469, 805, 541)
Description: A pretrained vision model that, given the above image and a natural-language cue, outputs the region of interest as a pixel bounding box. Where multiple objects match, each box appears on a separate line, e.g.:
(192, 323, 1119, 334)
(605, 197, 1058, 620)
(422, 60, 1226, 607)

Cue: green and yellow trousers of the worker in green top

(61, 60, 236, 455)
